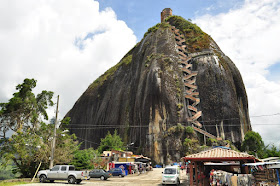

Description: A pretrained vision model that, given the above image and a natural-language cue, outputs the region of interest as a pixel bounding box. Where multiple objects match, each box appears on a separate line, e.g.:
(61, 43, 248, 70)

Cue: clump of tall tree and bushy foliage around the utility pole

(0, 79, 79, 177)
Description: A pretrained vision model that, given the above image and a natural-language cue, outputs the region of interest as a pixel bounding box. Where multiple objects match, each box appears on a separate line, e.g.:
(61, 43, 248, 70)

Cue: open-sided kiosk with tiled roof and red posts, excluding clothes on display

(183, 147, 259, 185)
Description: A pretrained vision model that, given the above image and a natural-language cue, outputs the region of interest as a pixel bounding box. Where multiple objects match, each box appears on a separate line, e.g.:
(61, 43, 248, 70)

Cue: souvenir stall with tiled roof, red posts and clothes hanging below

(183, 147, 259, 186)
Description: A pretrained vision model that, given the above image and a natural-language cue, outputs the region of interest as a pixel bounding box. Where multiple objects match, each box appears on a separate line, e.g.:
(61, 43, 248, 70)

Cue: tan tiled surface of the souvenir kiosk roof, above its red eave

(185, 148, 255, 159)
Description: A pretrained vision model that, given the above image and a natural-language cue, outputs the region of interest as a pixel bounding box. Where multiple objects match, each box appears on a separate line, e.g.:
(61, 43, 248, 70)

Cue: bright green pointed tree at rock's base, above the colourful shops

(98, 130, 125, 153)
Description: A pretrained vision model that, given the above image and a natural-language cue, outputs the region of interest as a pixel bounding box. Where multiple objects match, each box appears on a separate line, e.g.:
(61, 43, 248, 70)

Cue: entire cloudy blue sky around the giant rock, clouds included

(0, 0, 280, 146)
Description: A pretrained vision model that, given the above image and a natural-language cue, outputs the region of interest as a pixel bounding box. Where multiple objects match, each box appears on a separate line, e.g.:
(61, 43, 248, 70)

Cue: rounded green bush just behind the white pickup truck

(71, 148, 101, 170)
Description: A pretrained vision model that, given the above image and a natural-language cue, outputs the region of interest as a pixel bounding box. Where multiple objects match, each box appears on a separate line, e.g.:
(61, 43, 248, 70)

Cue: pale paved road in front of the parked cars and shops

(16, 168, 187, 186)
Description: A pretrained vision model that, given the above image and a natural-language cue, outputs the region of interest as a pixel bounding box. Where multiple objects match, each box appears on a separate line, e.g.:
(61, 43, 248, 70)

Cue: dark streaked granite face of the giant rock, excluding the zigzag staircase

(66, 16, 251, 163)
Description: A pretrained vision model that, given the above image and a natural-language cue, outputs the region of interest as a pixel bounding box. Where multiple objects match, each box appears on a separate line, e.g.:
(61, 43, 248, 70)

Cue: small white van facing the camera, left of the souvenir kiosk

(162, 166, 180, 185)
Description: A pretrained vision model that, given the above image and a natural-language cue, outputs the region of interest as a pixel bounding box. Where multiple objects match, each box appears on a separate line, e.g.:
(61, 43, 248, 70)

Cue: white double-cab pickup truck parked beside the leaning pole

(37, 165, 89, 184)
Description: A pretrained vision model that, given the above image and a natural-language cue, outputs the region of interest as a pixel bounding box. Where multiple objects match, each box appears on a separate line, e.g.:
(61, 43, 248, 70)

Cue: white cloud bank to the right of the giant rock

(195, 0, 280, 146)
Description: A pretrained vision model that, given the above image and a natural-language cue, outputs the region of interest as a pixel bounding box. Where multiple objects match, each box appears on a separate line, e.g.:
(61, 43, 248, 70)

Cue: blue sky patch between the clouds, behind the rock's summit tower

(98, 0, 243, 41)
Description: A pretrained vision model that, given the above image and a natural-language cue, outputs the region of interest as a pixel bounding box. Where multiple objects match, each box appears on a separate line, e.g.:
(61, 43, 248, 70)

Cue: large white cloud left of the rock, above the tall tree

(0, 0, 136, 117)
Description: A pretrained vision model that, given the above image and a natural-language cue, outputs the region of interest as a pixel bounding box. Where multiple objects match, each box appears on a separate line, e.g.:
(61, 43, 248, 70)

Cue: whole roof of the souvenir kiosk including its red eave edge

(184, 147, 256, 161)
